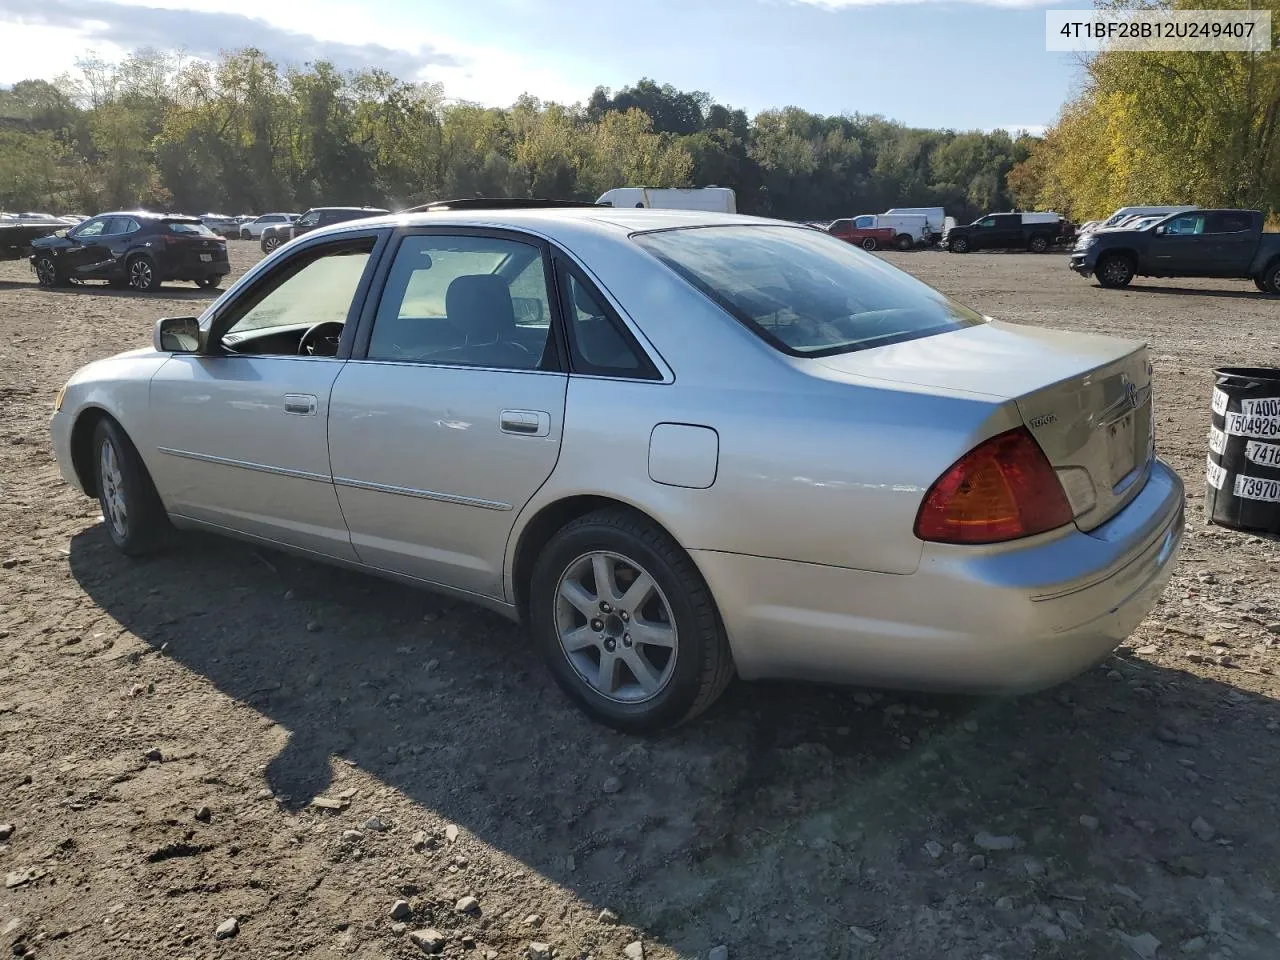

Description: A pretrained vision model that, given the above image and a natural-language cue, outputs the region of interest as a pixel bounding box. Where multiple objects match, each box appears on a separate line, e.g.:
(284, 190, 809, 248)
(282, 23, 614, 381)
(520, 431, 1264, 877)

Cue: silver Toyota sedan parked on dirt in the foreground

(52, 205, 1183, 731)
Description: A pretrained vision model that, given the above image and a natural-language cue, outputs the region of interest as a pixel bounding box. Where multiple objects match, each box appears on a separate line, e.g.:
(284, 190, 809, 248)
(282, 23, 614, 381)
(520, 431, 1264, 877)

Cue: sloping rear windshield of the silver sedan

(635, 225, 983, 357)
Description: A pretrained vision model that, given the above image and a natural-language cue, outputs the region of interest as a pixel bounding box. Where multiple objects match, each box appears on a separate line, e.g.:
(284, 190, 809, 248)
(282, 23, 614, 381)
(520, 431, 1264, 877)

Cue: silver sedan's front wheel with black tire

(93, 417, 169, 557)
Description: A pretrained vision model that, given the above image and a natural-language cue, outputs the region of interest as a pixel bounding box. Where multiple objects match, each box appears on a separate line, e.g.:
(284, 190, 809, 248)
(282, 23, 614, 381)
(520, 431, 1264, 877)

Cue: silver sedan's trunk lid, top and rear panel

(817, 321, 1155, 531)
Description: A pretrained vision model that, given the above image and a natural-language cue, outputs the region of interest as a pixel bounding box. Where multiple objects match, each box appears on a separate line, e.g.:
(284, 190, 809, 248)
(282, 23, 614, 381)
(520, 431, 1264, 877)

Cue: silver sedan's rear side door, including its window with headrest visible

(329, 230, 567, 598)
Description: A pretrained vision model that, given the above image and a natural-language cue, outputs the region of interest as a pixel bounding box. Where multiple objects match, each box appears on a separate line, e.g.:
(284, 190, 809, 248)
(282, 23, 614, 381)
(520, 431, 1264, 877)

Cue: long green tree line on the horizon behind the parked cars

(0, 50, 1034, 219)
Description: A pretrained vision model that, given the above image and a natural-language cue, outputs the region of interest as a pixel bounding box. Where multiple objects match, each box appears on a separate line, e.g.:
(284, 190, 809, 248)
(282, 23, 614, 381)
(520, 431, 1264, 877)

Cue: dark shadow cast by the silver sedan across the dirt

(69, 525, 1280, 960)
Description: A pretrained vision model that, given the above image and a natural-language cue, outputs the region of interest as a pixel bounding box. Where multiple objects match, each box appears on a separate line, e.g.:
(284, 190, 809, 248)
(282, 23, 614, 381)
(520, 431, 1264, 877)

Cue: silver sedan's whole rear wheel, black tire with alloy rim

(529, 508, 733, 733)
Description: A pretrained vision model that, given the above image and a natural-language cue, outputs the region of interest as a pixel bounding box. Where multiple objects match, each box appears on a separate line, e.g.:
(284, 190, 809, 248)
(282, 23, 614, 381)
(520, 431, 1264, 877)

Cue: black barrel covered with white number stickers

(1204, 366, 1280, 534)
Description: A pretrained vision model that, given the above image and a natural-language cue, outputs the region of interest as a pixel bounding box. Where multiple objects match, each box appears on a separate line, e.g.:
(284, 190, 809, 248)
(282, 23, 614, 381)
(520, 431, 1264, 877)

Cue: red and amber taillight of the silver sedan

(915, 426, 1073, 543)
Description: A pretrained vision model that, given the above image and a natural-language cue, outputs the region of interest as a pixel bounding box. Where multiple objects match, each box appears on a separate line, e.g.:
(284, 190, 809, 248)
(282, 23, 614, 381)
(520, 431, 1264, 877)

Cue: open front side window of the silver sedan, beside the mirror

(224, 238, 374, 353)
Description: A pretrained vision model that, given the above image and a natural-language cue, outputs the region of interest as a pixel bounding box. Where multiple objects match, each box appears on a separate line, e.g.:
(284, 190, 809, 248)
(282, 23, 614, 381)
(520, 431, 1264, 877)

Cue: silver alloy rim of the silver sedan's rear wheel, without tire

(556, 550, 678, 703)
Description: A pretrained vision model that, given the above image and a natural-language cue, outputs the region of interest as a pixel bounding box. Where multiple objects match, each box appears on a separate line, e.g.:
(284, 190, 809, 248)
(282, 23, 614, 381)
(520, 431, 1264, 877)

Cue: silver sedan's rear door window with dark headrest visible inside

(367, 236, 552, 370)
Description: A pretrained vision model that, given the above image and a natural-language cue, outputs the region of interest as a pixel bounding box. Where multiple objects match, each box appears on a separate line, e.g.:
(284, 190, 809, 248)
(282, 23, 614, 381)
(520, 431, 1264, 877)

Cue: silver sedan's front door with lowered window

(147, 234, 376, 559)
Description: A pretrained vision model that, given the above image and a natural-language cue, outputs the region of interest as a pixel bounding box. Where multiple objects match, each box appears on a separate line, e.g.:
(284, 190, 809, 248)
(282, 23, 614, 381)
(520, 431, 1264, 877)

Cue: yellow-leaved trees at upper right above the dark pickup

(1007, 0, 1280, 223)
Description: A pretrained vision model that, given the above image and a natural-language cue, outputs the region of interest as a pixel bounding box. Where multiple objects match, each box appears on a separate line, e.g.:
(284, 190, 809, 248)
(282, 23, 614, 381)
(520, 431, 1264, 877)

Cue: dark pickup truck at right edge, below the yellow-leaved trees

(1070, 210, 1280, 293)
